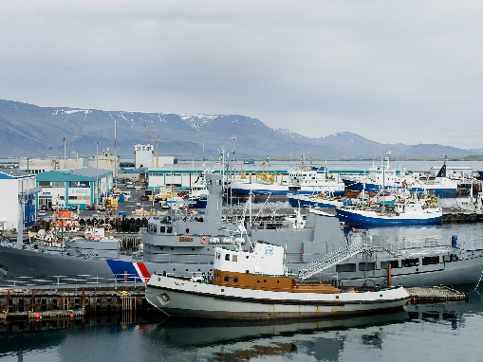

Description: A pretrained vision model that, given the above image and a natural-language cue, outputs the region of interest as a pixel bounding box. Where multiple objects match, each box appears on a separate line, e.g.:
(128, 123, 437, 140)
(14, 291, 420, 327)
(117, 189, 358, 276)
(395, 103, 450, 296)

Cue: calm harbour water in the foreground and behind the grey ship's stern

(0, 224, 483, 362)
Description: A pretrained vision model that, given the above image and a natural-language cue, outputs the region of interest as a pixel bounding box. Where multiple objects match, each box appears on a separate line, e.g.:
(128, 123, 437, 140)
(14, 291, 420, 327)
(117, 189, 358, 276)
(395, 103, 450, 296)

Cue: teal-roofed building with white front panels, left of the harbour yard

(37, 167, 113, 209)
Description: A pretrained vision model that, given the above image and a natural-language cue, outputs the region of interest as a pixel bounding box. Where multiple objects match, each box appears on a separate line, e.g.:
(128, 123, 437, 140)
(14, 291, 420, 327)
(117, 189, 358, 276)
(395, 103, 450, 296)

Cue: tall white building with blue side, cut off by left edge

(0, 170, 37, 230)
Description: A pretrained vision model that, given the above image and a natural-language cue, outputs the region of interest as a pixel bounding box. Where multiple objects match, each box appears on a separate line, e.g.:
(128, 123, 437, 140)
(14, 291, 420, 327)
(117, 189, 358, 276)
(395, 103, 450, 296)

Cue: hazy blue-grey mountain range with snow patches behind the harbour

(0, 100, 483, 159)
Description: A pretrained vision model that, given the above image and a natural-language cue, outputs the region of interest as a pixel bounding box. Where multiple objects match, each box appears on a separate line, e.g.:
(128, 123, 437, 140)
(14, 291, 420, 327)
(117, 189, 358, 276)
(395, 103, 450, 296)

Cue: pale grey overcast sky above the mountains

(0, 0, 483, 148)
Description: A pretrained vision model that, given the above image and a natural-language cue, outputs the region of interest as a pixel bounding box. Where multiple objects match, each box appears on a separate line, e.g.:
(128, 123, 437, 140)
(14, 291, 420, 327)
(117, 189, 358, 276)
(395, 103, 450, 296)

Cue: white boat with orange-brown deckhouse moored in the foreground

(146, 243, 409, 320)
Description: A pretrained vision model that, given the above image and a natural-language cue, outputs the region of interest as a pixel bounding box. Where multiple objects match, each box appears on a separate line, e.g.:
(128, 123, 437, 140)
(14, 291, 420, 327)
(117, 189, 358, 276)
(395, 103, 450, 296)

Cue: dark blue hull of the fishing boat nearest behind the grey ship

(336, 208, 442, 227)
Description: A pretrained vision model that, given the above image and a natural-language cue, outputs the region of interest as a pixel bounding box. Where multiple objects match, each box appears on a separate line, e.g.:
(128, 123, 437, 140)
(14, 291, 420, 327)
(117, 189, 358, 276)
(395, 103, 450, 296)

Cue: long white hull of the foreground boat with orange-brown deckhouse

(146, 275, 409, 320)
